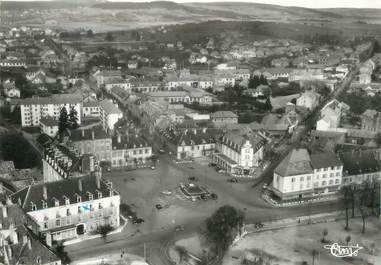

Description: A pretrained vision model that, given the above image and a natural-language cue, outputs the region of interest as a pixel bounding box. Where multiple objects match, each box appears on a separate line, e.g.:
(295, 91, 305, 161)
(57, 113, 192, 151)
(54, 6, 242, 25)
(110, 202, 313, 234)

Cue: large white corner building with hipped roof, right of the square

(272, 149, 343, 200)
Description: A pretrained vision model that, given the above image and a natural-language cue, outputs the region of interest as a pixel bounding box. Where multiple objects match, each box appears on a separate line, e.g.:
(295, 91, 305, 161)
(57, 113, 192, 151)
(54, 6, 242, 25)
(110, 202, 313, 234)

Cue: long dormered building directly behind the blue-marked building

(42, 144, 98, 182)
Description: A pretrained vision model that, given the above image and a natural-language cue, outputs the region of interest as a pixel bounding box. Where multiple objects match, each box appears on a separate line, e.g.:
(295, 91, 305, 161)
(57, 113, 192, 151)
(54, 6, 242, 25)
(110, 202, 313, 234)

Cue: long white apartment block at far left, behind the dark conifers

(17, 94, 82, 127)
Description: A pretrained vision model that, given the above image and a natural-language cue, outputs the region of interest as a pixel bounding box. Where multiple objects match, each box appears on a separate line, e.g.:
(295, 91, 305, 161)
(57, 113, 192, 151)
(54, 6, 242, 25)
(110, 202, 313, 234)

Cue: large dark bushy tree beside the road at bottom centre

(206, 205, 245, 252)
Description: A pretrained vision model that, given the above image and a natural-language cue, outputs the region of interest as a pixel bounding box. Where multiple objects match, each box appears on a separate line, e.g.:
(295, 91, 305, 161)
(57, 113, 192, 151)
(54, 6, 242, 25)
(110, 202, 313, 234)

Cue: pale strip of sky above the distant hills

(5, 0, 381, 9)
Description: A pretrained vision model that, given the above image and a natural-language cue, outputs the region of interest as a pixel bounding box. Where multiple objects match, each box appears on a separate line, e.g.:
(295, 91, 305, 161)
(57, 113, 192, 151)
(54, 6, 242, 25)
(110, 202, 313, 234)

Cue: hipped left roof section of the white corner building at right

(274, 149, 313, 177)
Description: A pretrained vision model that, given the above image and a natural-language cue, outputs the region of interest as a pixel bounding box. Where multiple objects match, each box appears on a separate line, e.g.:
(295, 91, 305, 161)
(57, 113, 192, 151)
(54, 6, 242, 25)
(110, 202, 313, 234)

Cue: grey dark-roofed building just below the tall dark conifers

(70, 127, 111, 161)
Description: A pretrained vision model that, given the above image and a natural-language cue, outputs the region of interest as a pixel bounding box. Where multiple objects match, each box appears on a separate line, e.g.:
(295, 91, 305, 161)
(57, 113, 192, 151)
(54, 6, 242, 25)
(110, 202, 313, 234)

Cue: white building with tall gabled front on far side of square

(213, 129, 266, 176)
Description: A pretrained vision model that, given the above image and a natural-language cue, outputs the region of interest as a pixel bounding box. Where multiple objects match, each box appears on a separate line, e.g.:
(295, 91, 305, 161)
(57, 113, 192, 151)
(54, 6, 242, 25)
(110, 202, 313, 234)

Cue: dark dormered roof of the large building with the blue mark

(11, 175, 118, 212)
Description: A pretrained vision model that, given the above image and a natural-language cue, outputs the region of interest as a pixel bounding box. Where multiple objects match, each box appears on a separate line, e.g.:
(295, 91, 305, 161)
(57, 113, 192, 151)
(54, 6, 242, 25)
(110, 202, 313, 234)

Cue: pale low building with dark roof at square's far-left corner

(111, 134, 152, 167)
